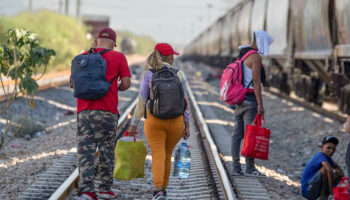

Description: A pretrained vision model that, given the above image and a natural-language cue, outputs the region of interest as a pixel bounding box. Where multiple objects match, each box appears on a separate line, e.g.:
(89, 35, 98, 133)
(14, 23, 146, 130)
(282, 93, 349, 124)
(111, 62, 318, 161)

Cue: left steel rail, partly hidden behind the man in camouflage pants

(49, 97, 138, 200)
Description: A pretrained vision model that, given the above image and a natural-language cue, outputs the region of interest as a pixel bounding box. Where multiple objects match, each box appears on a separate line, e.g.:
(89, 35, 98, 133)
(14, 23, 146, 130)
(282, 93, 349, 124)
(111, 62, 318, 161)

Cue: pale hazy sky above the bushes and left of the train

(0, 0, 238, 47)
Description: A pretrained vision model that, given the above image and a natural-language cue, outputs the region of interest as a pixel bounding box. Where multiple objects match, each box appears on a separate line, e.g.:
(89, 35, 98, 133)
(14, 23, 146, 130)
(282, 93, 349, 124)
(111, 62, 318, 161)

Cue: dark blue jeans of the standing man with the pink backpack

(231, 100, 258, 171)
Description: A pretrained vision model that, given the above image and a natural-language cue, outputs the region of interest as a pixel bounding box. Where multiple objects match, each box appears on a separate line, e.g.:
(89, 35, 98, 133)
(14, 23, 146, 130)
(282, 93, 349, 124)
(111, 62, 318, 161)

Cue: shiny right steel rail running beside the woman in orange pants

(186, 82, 236, 200)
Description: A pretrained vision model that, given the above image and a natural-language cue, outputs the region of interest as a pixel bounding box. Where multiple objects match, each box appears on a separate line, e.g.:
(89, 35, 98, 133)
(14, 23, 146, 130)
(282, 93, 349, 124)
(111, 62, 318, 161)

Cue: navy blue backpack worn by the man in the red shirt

(71, 48, 114, 100)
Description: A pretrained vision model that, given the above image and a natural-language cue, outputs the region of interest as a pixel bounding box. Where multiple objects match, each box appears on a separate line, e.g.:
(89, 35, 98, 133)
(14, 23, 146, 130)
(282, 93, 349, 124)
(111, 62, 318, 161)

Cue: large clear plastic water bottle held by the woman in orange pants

(174, 142, 191, 178)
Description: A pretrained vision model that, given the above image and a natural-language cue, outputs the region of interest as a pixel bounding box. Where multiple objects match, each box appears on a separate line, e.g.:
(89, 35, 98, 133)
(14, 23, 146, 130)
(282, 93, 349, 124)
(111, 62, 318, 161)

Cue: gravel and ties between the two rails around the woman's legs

(69, 115, 223, 200)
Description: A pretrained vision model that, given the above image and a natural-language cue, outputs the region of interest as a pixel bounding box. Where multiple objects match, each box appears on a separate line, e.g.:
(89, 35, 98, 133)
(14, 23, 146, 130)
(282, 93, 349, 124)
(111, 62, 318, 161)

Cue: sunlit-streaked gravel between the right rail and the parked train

(180, 62, 350, 199)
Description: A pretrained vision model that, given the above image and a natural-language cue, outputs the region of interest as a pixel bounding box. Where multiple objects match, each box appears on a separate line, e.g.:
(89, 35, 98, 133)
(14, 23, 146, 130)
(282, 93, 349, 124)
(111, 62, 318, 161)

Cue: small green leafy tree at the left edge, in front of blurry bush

(0, 28, 55, 150)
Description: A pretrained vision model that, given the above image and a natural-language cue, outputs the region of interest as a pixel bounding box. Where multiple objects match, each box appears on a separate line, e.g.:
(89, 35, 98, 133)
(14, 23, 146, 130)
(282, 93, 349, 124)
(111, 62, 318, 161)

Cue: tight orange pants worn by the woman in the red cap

(144, 110, 184, 188)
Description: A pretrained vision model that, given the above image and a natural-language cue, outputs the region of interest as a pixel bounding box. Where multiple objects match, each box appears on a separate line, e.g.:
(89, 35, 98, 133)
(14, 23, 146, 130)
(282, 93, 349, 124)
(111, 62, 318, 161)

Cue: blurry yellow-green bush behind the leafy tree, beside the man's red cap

(0, 11, 91, 71)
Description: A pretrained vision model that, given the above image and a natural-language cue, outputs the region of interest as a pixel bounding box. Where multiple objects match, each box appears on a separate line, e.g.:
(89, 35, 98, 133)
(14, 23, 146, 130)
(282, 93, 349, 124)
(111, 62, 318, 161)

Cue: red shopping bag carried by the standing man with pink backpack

(241, 114, 271, 160)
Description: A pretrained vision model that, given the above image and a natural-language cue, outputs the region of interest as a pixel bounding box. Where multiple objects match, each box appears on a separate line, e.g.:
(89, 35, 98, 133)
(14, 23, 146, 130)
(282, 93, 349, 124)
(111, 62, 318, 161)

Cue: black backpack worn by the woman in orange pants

(149, 67, 186, 119)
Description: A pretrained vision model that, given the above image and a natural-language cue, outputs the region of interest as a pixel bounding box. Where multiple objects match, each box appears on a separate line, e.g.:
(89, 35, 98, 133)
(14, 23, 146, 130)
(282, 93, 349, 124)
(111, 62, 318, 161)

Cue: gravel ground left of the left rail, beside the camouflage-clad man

(0, 68, 139, 200)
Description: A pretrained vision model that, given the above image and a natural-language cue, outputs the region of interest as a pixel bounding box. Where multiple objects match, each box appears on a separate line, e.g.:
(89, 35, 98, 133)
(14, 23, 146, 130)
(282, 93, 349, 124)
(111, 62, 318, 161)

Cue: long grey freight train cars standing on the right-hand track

(183, 0, 350, 112)
